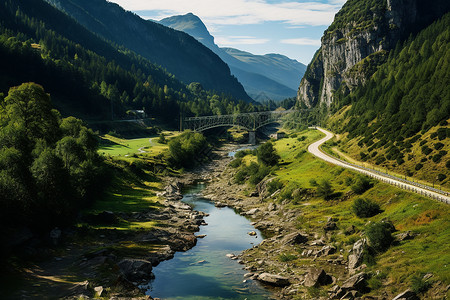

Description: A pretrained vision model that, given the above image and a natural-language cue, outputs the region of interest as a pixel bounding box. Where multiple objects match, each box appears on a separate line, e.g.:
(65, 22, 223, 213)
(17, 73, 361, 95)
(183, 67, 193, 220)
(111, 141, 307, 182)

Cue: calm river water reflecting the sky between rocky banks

(147, 184, 270, 300)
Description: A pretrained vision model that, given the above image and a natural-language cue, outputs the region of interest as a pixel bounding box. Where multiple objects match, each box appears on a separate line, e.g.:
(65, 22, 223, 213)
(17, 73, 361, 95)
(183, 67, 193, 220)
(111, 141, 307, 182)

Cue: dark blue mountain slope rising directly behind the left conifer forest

(47, 0, 251, 101)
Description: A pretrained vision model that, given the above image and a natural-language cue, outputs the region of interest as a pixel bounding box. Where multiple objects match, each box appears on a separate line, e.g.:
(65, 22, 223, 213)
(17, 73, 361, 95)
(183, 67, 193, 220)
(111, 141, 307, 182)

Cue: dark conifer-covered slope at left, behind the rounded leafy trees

(0, 0, 257, 125)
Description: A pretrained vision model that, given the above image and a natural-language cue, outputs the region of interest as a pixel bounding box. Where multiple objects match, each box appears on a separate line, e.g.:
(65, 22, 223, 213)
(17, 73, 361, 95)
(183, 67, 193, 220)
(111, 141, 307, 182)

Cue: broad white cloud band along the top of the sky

(110, 0, 345, 27)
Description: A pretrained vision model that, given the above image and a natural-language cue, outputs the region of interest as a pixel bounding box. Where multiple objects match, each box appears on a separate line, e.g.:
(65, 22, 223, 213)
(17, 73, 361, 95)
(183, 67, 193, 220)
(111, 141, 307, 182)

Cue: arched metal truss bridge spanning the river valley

(182, 110, 306, 144)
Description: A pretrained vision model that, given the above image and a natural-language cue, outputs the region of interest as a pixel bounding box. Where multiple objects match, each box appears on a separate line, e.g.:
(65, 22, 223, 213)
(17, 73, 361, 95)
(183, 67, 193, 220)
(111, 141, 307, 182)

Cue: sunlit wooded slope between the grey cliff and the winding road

(331, 13, 450, 185)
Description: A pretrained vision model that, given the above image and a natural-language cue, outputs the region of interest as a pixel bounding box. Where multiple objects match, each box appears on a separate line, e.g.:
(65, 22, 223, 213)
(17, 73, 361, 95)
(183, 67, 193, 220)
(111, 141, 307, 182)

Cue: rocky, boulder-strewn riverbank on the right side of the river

(199, 145, 385, 299)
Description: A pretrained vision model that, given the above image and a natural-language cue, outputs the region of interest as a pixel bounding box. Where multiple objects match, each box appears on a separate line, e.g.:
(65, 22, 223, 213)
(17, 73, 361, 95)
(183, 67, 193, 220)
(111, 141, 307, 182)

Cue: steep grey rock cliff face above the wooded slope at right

(297, 0, 450, 107)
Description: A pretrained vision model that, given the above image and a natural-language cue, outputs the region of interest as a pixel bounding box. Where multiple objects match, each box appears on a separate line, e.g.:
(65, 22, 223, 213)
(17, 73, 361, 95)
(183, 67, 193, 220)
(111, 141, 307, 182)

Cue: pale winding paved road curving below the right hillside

(308, 127, 450, 204)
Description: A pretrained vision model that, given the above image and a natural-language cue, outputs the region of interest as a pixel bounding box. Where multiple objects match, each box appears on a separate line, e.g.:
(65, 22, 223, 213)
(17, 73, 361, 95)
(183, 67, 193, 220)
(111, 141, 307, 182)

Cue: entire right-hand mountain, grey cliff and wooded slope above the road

(297, 0, 450, 186)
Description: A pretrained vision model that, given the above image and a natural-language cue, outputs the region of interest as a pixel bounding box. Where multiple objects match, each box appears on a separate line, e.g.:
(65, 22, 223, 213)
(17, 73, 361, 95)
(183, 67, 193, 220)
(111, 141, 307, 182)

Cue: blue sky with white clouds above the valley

(109, 0, 346, 65)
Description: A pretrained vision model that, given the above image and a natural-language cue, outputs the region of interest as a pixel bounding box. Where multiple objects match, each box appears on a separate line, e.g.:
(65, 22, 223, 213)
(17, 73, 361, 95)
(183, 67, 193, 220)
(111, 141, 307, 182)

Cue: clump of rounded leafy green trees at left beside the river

(0, 83, 106, 239)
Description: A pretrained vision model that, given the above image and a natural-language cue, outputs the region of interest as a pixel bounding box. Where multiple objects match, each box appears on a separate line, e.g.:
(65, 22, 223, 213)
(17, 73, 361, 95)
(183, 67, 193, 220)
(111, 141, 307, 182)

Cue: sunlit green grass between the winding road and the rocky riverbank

(268, 131, 450, 295)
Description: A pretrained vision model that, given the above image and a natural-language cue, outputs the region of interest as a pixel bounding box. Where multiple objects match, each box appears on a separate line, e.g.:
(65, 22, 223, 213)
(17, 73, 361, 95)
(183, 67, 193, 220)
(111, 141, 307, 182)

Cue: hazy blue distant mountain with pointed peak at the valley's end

(159, 13, 306, 100)
